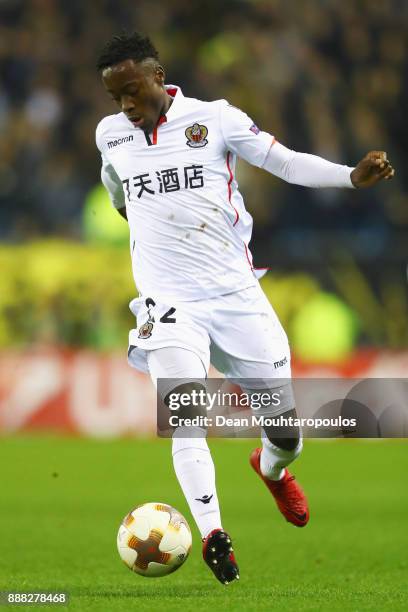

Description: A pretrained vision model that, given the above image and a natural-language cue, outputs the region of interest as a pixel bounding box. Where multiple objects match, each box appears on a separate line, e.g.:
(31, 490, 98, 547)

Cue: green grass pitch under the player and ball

(0, 436, 408, 612)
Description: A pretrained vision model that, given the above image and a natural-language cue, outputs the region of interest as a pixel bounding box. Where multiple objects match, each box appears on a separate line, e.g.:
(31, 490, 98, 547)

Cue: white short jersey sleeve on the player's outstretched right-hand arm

(220, 100, 274, 167)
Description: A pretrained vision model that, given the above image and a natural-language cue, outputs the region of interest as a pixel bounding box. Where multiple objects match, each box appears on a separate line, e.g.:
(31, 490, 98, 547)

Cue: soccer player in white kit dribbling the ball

(96, 33, 394, 584)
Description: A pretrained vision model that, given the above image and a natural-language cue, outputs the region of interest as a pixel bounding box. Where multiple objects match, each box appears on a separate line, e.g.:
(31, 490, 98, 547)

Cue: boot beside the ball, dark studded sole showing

(203, 529, 239, 584)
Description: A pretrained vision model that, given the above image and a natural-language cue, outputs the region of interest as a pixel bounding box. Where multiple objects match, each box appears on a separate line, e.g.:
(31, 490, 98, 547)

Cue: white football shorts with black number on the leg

(128, 283, 291, 389)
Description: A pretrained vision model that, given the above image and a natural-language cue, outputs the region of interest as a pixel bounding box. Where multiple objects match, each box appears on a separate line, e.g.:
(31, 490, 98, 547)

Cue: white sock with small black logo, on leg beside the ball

(173, 427, 222, 538)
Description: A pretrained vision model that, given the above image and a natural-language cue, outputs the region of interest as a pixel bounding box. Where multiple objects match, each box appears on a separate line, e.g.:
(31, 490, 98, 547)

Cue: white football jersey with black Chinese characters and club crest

(96, 85, 274, 301)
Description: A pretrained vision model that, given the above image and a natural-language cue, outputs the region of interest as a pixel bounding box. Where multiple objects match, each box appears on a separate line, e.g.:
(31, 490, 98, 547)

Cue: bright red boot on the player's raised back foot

(249, 448, 309, 527)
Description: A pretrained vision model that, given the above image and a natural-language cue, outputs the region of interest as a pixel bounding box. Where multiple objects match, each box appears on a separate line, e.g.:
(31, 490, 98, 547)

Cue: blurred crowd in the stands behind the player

(0, 0, 408, 358)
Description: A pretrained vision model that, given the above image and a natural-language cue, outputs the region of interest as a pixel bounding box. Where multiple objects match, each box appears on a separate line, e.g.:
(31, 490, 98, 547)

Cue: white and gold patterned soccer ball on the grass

(117, 502, 191, 577)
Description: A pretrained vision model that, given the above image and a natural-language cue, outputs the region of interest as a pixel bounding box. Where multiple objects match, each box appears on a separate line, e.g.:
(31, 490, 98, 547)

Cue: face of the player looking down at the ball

(102, 59, 166, 132)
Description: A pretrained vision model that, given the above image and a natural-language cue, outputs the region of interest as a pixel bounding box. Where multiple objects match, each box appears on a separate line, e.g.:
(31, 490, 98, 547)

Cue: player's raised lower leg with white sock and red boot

(250, 410, 309, 527)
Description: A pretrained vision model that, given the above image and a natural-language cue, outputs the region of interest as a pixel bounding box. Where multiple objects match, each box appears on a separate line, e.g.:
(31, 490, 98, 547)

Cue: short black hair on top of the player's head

(96, 32, 159, 71)
